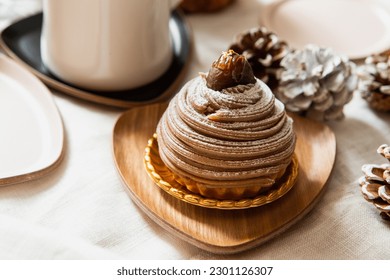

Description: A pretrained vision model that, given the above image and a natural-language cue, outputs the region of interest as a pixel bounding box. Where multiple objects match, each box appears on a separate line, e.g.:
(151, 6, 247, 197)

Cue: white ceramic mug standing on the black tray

(41, 0, 179, 91)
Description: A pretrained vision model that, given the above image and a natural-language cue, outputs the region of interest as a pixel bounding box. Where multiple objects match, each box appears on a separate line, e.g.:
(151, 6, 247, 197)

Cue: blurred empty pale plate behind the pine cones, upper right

(260, 0, 390, 60)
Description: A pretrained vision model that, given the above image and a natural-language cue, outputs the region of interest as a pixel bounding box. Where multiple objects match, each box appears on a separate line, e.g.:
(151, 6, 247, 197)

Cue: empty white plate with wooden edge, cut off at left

(0, 54, 64, 185)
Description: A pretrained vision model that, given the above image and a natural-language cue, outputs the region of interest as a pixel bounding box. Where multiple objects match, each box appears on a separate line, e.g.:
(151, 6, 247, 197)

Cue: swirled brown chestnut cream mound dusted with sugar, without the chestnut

(157, 77, 295, 188)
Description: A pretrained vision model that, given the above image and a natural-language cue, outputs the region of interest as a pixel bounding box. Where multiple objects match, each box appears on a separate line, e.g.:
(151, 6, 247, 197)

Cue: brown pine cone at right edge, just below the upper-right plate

(359, 53, 390, 111)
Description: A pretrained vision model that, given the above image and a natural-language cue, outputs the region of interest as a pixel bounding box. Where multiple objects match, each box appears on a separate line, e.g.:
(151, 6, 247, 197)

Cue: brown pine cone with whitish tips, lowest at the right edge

(359, 145, 390, 221)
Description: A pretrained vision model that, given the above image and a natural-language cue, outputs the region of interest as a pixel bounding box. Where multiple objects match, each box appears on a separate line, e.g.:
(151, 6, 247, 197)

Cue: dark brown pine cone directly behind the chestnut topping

(229, 27, 289, 89)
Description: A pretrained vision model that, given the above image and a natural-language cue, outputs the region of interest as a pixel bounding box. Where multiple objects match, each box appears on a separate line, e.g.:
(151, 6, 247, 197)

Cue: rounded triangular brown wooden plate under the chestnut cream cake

(113, 104, 336, 253)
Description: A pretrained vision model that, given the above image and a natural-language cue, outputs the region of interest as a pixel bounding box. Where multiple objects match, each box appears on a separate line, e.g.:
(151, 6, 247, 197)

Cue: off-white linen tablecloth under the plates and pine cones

(0, 0, 390, 259)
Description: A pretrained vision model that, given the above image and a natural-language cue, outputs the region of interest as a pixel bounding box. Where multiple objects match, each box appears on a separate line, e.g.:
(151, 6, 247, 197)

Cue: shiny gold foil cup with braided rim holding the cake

(144, 134, 298, 210)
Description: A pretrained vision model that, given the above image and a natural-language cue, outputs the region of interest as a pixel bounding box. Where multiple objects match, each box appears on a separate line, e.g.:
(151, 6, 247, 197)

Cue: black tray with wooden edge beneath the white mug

(0, 10, 192, 108)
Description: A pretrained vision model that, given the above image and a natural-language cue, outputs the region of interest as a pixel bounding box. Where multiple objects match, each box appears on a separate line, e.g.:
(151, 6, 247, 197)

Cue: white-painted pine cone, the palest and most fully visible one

(275, 45, 358, 120)
